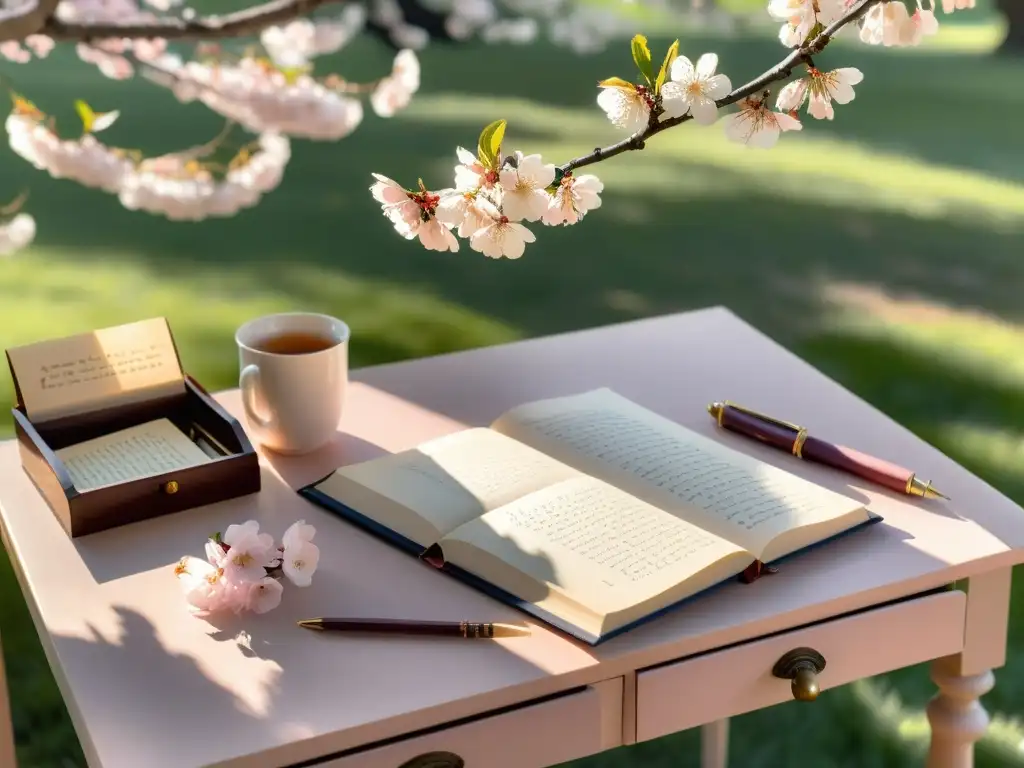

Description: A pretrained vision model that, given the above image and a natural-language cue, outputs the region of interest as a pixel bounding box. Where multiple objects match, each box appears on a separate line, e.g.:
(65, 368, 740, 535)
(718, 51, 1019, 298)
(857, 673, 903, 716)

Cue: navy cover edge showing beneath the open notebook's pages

(298, 477, 882, 645)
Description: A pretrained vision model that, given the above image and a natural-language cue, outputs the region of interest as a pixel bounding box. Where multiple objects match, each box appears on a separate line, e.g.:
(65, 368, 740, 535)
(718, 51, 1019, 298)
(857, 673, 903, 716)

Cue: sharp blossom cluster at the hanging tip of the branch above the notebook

(370, 120, 604, 259)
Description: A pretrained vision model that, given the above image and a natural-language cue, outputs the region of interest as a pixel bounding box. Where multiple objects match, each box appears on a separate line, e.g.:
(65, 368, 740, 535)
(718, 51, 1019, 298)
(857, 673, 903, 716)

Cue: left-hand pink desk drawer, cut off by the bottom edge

(316, 678, 623, 768)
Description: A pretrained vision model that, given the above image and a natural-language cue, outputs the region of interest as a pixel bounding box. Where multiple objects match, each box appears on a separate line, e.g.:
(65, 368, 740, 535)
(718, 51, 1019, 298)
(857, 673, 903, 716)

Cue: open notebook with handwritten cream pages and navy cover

(299, 389, 881, 644)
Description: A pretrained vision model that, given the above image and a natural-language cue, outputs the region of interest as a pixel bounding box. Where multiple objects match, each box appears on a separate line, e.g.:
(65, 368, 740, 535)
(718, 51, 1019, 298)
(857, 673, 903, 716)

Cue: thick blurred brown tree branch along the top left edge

(25, 0, 343, 40)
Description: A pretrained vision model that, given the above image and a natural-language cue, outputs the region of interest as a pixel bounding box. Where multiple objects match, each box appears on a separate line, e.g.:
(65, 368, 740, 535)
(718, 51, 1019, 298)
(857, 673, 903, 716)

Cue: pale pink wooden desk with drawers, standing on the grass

(0, 309, 1024, 768)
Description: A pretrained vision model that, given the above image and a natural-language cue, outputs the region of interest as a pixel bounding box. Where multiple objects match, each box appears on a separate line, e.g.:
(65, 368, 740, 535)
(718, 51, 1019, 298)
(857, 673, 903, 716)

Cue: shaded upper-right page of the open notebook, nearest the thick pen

(494, 389, 862, 554)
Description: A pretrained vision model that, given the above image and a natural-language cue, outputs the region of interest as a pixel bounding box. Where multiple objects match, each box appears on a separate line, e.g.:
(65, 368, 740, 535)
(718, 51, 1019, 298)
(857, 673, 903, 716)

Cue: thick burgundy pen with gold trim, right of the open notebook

(708, 400, 949, 499)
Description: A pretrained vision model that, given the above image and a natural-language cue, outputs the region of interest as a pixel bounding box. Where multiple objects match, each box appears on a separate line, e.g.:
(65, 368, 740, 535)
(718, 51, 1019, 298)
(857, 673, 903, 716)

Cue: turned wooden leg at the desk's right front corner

(928, 656, 995, 768)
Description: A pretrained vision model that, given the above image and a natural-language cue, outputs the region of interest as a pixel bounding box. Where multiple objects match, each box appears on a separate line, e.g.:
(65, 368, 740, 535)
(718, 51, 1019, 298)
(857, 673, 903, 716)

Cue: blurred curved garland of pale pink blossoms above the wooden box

(6, 98, 291, 221)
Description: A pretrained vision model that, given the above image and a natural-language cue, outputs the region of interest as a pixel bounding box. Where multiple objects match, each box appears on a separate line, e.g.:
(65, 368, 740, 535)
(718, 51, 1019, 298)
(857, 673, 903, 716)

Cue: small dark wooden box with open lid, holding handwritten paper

(7, 318, 260, 537)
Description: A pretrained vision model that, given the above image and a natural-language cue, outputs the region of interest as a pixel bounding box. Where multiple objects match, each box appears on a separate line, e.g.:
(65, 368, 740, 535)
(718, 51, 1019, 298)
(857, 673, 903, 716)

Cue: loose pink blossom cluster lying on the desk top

(174, 520, 319, 616)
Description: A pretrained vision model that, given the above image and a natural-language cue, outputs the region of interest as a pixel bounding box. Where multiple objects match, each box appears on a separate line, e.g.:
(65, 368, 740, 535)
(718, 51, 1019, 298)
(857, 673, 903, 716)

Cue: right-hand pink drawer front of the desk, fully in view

(636, 592, 967, 741)
